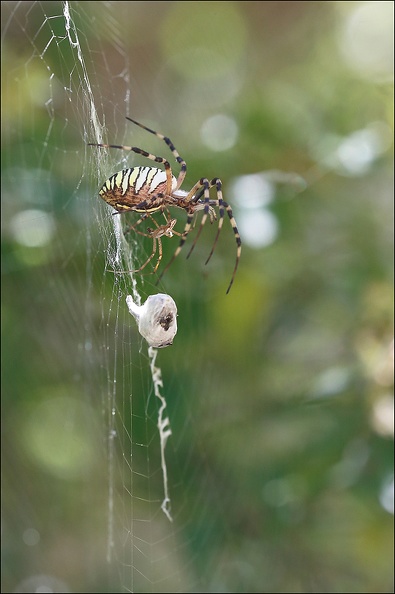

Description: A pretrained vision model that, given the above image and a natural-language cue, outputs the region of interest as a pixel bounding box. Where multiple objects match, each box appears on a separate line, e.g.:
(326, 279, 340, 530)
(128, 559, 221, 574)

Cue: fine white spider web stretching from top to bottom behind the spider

(2, 2, 232, 591)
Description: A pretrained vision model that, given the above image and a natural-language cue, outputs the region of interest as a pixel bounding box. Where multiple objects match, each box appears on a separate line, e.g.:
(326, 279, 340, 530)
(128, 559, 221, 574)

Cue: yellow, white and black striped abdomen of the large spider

(99, 167, 177, 212)
